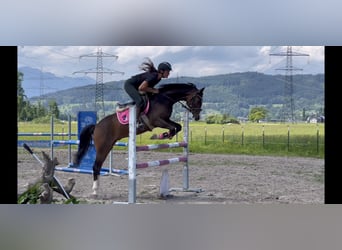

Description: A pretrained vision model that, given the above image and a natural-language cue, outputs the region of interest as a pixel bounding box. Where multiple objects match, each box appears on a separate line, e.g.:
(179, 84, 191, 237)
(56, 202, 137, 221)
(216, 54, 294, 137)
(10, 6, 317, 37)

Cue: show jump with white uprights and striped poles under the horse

(128, 105, 203, 203)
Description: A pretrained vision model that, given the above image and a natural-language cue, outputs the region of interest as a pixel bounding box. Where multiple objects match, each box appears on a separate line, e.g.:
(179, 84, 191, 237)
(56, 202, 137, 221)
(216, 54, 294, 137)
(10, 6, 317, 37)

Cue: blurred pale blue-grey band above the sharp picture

(0, 0, 342, 46)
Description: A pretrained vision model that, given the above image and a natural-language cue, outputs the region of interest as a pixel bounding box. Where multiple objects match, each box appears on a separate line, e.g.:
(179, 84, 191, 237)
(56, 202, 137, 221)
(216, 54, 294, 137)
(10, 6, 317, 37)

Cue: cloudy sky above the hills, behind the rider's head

(18, 46, 324, 82)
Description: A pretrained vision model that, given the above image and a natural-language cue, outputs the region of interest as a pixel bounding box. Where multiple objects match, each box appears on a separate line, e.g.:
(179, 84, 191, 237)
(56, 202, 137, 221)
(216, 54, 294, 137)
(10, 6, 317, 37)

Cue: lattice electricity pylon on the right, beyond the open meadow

(270, 46, 309, 122)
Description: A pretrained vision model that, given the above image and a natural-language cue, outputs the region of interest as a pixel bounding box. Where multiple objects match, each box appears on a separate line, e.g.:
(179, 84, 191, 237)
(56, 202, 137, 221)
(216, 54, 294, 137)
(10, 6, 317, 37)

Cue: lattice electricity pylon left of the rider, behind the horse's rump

(73, 48, 124, 118)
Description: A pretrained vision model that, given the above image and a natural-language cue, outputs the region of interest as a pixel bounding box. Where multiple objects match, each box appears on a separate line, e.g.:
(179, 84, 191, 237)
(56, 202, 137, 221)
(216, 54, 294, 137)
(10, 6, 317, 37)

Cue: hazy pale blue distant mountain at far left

(18, 67, 95, 98)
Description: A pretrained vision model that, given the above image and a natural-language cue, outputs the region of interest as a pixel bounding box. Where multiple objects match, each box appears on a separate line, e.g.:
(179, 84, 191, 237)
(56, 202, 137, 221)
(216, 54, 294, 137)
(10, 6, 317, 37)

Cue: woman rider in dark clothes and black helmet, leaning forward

(124, 58, 172, 130)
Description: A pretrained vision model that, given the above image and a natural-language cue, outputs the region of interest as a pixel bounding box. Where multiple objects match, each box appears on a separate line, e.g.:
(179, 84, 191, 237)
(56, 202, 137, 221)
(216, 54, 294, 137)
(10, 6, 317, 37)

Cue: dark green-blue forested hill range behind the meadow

(24, 72, 324, 119)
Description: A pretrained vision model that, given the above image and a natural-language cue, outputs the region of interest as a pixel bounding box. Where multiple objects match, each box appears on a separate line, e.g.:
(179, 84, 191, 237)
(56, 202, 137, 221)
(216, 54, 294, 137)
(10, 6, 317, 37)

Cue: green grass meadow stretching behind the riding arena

(18, 122, 325, 158)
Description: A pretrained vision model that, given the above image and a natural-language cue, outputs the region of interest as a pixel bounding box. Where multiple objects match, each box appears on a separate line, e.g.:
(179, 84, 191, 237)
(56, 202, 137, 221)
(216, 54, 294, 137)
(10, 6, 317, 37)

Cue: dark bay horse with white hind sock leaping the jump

(74, 83, 205, 195)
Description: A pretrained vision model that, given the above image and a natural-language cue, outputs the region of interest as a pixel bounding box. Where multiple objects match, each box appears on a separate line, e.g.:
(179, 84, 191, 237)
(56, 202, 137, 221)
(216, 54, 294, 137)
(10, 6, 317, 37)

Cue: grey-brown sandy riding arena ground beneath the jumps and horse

(18, 149, 324, 204)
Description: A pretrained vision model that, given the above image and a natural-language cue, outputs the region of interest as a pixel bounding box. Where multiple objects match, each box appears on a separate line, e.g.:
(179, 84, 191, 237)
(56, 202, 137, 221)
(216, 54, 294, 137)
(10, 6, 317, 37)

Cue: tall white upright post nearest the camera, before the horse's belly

(128, 105, 137, 203)
